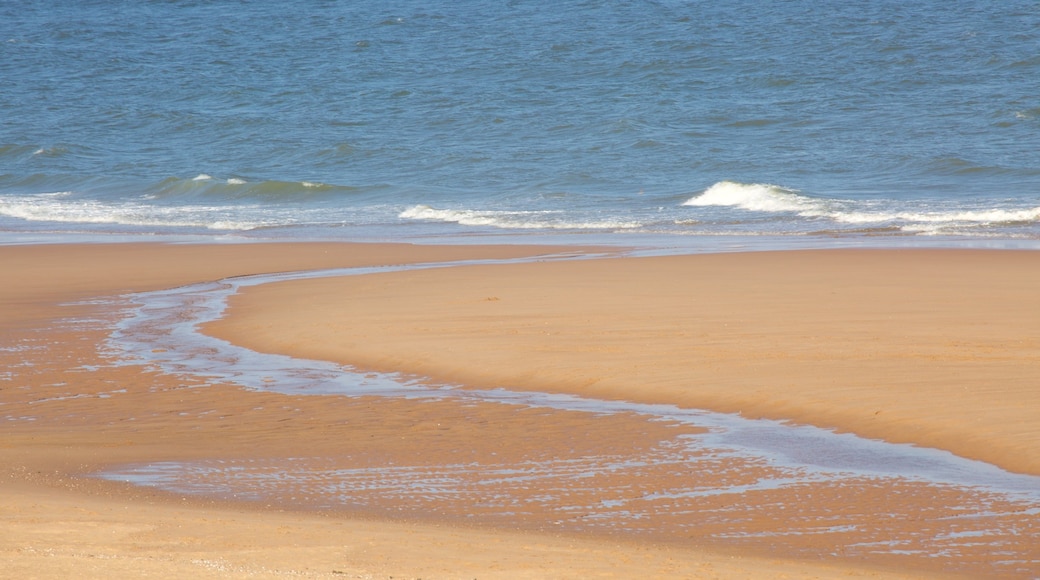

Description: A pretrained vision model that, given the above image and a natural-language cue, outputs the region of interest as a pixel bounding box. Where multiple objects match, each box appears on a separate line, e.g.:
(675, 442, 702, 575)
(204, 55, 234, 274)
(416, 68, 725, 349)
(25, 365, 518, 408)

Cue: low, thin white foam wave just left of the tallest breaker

(398, 205, 643, 230)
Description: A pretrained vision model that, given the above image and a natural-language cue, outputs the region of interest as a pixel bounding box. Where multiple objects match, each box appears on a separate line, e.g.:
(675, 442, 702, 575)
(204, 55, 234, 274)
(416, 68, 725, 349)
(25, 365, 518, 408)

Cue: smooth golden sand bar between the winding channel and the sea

(208, 251, 1040, 474)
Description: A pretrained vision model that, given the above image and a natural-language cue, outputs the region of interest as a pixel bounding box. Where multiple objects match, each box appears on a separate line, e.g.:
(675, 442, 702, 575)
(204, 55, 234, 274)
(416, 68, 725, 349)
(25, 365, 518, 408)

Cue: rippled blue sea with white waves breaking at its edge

(0, 0, 1040, 247)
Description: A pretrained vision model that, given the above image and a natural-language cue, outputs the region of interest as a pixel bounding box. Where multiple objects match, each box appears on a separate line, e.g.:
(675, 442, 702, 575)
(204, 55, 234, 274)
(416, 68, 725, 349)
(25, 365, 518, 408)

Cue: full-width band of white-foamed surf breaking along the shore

(0, 174, 1040, 238)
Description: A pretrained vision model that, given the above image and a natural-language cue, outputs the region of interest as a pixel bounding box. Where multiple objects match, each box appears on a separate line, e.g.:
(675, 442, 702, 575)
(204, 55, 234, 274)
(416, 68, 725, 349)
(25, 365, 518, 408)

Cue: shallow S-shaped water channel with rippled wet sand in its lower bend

(93, 257, 1040, 577)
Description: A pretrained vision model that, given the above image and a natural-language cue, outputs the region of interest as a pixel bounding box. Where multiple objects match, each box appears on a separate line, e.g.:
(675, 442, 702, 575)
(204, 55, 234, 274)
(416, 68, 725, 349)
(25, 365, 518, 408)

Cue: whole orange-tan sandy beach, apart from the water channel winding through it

(0, 243, 1040, 578)
